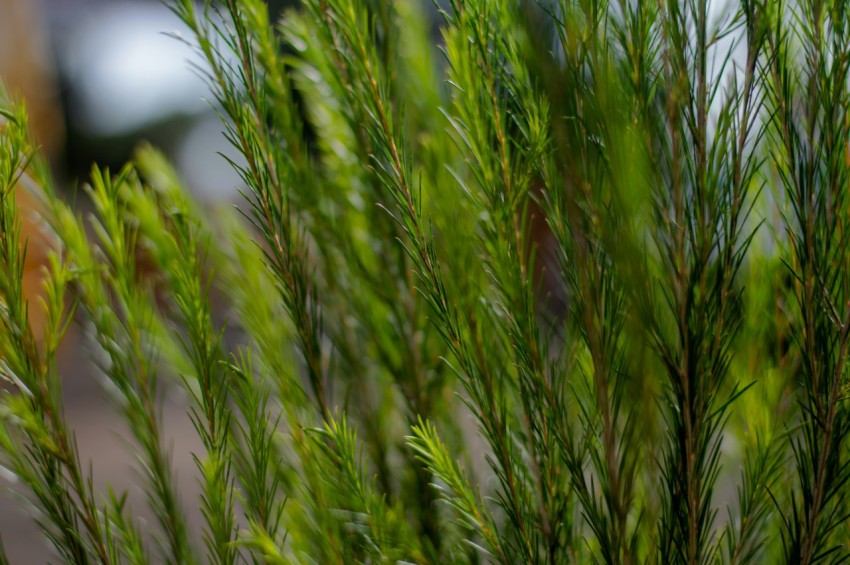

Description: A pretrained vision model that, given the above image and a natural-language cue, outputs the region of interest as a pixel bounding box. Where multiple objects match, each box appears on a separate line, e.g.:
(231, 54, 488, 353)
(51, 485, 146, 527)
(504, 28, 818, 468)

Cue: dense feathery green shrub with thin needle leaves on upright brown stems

(0, 0, 850, 564)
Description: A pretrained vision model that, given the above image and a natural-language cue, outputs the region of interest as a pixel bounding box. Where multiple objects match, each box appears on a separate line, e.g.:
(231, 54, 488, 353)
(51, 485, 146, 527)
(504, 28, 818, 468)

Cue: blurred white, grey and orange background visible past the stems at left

(0, 0, 294, 564)
